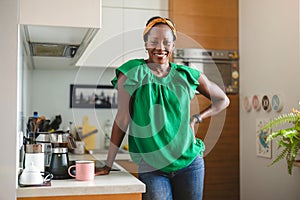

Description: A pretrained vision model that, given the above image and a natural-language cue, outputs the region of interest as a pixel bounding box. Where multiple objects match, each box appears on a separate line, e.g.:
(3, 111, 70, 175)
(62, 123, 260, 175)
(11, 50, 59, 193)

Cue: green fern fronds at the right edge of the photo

(262, 109, 300, 175)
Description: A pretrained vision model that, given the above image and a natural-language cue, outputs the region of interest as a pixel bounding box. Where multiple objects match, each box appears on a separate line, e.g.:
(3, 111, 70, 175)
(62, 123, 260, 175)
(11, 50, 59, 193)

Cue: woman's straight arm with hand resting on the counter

(96, 74, 130, 175)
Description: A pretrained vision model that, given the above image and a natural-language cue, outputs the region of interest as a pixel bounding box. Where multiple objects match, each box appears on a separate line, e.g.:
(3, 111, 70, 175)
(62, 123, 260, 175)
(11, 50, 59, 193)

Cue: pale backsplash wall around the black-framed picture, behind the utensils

(26, 67, 127, 149)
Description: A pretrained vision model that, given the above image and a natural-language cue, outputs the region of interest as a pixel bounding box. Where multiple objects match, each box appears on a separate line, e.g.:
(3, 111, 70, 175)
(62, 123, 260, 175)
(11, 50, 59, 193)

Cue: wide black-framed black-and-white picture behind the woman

(70, 84, 118, 108)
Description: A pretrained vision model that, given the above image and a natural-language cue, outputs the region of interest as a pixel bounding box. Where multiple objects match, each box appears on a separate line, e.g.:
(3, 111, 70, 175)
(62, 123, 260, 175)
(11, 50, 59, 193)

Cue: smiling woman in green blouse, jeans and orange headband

(97, 17, 229, 200)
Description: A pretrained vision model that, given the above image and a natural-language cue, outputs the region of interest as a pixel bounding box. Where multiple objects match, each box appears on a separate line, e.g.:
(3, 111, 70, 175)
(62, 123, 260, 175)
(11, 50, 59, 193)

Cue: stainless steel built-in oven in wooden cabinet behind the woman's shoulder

(173, 48, 239, 94)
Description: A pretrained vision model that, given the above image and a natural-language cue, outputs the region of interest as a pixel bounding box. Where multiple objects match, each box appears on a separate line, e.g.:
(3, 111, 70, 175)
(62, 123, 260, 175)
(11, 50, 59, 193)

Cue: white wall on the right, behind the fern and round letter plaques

(239, 0, 300, 200)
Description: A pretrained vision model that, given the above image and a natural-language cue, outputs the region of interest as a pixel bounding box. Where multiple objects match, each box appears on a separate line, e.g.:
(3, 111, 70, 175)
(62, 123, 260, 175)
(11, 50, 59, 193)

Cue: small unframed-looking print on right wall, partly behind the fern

(256, 119, 272, 158)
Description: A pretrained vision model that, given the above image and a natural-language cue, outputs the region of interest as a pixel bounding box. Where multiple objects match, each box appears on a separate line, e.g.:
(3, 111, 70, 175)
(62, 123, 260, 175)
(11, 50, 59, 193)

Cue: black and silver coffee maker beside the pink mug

(49, 131, 70, 179)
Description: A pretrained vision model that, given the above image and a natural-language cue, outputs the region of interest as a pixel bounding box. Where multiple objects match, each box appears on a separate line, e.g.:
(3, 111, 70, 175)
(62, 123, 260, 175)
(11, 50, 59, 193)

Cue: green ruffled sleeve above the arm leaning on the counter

(111, 59, 145, 95)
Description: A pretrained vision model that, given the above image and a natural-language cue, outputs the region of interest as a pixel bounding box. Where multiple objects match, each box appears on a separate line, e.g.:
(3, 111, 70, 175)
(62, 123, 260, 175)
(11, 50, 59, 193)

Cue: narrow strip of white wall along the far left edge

(0, 0, 18, 200)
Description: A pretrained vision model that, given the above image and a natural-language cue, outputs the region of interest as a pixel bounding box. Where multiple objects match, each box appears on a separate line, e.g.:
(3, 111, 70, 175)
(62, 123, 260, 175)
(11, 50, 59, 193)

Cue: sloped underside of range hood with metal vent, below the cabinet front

(22, 25, 98, 69)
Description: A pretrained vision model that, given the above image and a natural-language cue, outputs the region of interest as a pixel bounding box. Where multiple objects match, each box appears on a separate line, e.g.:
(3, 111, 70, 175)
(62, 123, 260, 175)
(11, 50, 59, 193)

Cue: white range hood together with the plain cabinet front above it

(20, 0, 101, 69)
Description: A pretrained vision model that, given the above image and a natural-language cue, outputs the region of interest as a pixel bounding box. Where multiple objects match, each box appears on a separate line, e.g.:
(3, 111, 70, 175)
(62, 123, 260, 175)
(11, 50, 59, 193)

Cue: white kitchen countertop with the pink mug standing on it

(17, 154, 145, 199)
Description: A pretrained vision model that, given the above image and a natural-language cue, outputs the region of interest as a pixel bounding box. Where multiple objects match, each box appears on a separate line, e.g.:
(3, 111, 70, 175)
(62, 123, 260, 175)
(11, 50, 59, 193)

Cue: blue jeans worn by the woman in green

(139, 156, 204, 200)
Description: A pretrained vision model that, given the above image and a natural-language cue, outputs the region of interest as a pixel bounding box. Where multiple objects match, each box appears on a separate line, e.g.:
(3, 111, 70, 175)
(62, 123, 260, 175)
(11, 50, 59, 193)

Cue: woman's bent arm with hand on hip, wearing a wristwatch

(192, 74, 230, 123)
